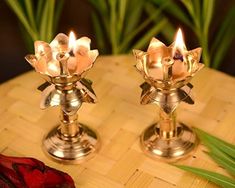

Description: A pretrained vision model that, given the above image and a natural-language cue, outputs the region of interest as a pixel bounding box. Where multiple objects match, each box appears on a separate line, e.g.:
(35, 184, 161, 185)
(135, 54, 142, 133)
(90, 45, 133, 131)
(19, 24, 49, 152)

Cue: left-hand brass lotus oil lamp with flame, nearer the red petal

(26, 33, 100, 163)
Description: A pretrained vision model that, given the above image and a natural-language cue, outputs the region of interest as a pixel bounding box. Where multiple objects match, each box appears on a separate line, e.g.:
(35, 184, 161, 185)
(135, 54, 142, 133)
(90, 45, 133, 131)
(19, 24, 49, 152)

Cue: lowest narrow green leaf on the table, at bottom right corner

(175, 165, 235, 188)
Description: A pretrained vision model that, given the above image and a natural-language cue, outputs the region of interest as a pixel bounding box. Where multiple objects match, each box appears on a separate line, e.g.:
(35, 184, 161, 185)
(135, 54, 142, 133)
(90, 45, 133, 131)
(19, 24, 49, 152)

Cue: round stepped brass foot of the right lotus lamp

(140, 123, 199, 162)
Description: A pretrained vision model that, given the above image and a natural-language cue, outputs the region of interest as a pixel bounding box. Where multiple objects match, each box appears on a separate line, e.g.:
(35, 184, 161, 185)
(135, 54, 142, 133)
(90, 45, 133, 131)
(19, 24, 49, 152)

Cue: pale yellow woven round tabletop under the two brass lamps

(0, 56, 235, 188)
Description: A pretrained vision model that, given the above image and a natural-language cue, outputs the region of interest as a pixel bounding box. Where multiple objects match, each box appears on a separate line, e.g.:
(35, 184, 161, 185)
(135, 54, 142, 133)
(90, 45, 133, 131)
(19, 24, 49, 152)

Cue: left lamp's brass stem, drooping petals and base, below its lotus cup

(42, 76, 100, 164)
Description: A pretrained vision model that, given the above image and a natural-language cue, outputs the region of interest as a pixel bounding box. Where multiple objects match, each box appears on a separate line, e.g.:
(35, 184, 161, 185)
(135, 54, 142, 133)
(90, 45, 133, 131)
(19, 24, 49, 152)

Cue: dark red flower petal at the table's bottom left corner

(0, 154, 75, 188)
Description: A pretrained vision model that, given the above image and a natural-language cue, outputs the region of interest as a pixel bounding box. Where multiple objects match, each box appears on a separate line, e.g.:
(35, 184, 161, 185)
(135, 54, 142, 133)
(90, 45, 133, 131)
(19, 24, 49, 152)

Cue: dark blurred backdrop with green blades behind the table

(0, 0, 235, 82)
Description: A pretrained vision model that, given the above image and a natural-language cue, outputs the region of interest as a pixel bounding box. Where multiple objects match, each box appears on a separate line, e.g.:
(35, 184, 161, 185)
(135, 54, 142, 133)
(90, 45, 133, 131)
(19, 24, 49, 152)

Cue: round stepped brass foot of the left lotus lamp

(43, 124, 100, 164)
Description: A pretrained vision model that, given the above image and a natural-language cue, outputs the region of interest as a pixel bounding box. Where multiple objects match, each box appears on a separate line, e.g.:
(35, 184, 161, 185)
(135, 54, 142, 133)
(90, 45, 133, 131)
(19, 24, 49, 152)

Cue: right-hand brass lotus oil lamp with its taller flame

(133, 29, 203, 162)
